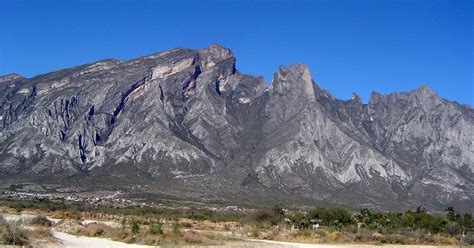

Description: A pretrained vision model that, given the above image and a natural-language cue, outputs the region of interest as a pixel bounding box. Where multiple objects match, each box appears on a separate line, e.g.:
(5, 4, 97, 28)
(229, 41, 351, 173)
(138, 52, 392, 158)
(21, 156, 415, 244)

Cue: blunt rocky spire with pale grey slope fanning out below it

(257, 65, 410, 205)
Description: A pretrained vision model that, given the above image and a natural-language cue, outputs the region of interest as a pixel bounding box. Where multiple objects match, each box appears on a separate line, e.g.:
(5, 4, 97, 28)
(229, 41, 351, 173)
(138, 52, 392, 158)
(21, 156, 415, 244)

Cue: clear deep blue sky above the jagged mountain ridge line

(0, 0, 474, 106)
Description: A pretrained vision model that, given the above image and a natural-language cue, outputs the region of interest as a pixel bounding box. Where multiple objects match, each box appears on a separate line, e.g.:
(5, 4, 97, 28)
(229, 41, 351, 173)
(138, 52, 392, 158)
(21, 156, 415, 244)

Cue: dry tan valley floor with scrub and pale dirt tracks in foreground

(0, 201, 473, 248)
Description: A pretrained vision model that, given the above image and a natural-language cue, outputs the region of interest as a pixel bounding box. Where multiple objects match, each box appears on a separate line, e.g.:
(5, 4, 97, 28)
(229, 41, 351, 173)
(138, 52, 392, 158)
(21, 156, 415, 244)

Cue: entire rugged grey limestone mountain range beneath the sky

(0, 45, 474, 210)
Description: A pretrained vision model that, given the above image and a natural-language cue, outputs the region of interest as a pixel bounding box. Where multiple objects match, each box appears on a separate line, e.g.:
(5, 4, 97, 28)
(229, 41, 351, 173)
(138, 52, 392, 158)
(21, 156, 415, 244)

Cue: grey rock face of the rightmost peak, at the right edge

(367, 86, 474, 204)
